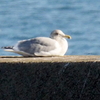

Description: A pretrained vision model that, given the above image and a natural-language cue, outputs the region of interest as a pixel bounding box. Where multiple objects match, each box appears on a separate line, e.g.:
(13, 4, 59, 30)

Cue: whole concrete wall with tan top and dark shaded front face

(0, 56, 100, 100)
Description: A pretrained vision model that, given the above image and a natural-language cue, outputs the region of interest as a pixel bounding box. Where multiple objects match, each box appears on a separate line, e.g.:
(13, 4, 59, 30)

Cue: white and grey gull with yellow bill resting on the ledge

(2, 30, 71, 57)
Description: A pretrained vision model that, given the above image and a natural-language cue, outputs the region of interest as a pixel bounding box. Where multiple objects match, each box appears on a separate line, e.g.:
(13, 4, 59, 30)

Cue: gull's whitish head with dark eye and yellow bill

(50, 30, 71, 39)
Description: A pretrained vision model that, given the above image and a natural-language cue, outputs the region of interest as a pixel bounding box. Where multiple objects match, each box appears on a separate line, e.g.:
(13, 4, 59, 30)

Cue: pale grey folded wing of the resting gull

(18, 37, 55, 54)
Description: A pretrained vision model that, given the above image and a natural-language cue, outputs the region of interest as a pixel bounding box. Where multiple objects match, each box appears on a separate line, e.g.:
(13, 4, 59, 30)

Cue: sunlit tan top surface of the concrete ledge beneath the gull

(0, 55, 100, 63)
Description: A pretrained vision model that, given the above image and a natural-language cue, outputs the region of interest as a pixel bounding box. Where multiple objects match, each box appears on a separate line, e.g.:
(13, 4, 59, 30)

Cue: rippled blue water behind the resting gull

(0, 0, 100, 55)
